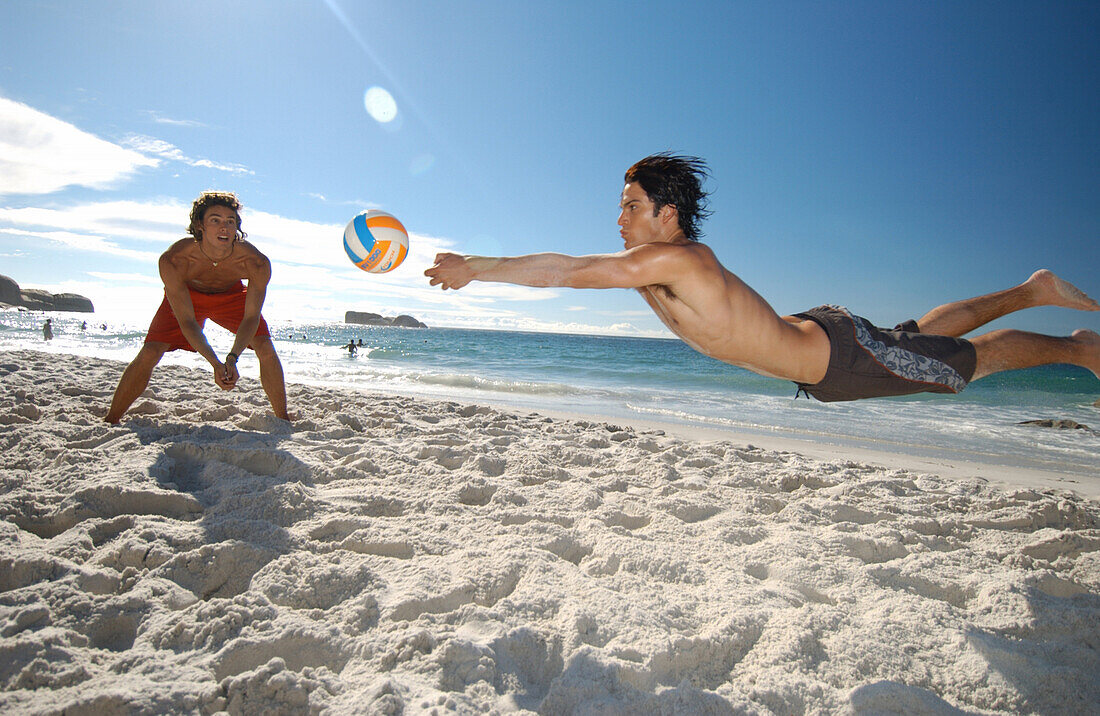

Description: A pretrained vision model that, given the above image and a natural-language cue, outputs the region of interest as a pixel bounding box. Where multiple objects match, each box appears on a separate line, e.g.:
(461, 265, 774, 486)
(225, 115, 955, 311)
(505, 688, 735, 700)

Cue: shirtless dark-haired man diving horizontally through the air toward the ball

(425, 154, 1100, 401)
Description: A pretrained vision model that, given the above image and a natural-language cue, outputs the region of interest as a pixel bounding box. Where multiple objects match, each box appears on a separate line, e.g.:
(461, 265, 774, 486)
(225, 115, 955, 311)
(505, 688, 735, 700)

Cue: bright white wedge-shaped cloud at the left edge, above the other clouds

(0, 97, 161, 196)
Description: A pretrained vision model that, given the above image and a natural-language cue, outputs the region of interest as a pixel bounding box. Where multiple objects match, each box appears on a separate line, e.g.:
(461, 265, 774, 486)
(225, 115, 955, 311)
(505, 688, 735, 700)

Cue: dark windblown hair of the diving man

(625, 152, 711, 241)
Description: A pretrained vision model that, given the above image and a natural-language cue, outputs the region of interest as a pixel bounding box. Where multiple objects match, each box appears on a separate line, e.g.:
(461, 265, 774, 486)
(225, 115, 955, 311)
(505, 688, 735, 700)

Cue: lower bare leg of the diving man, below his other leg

(970, 330, 1100, 381)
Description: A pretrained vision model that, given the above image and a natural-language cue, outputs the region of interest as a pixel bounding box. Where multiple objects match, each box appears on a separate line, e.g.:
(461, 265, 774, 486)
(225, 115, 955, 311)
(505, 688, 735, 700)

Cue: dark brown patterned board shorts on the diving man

(795, 306, 978, 403)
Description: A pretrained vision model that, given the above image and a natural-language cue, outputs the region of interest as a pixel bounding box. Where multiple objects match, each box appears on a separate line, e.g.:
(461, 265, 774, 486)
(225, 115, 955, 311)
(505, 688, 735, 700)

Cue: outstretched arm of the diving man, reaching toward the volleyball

(424, 245, 688, 290)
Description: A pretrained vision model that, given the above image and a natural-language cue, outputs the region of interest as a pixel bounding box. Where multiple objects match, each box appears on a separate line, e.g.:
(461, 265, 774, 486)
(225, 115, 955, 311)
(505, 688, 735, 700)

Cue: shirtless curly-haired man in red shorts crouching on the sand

(103, 191, 289, 422)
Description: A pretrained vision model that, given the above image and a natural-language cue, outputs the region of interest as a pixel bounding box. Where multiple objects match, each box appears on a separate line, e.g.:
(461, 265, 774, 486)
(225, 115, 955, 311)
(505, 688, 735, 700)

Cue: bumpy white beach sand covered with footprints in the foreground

(0, 351, 1100, 714)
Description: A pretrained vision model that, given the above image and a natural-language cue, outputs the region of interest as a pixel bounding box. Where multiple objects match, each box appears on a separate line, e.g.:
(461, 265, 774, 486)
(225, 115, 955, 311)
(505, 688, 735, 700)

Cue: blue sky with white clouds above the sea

(0, 0, 1100, 335)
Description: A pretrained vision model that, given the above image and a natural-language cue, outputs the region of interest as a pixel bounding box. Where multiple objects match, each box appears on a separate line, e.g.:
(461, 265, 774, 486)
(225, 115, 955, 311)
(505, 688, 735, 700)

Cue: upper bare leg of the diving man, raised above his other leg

(916, 268, 1100, 338)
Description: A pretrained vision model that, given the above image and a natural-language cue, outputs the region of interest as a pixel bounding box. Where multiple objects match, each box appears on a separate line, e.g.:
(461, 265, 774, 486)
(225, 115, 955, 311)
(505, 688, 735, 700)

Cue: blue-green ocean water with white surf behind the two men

(0, 310, 1100, 480)
